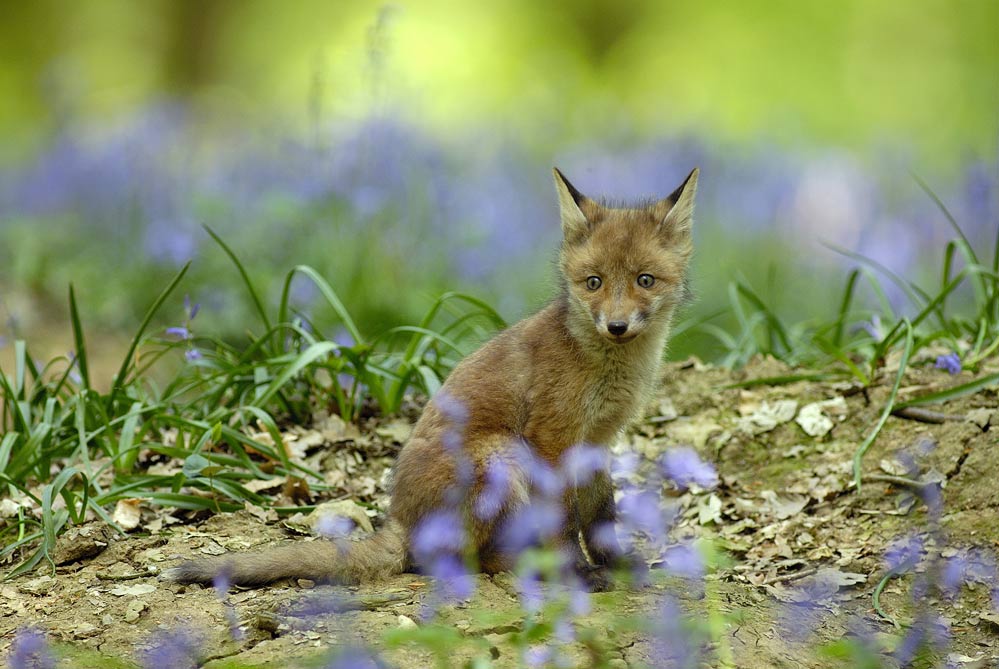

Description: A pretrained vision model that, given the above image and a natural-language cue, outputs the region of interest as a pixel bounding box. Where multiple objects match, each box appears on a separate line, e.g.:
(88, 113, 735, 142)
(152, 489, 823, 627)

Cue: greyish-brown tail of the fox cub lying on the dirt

(164, 520, 406, 585)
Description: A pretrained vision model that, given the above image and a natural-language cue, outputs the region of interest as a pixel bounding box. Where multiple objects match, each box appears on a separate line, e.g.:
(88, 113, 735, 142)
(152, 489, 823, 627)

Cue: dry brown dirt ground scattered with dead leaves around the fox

(0, 357, 999, 669)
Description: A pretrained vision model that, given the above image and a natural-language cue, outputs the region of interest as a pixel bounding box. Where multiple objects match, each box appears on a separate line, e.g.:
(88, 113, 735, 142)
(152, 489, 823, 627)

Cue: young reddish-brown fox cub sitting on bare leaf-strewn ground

(165, 168, 699, 590)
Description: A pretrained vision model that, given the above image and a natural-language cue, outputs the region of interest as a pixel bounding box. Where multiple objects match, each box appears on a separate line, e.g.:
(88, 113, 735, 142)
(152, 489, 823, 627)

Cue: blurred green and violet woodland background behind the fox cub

(0, 0, 999, 376)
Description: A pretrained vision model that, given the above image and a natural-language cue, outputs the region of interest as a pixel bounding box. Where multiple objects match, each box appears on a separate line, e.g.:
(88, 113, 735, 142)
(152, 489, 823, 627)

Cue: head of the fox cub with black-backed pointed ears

(555, 169, 697, 344)
